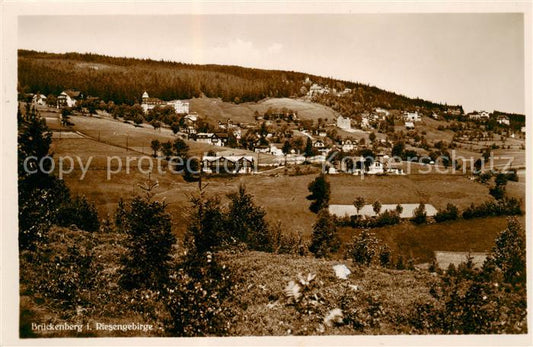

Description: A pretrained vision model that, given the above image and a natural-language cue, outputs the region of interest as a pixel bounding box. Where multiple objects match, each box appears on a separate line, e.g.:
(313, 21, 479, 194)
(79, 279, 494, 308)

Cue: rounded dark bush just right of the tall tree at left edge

(56, 196, 100, 231)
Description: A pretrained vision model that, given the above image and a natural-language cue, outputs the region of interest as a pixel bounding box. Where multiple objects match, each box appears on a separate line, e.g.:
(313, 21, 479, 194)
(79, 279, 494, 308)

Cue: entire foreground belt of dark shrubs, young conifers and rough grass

(18, 96, 527, 337)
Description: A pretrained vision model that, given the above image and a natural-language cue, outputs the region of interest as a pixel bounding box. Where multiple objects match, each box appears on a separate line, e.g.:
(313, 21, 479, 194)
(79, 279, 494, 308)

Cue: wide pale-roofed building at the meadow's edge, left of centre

(202, 155, 256, 174)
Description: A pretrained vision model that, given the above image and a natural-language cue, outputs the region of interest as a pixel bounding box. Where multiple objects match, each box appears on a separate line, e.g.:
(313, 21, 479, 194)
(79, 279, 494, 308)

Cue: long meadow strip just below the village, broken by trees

(53, 133, 504, 239)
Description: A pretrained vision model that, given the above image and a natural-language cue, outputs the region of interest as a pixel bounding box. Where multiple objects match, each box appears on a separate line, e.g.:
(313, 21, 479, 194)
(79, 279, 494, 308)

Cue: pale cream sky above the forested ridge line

(18, 14, 525, 114)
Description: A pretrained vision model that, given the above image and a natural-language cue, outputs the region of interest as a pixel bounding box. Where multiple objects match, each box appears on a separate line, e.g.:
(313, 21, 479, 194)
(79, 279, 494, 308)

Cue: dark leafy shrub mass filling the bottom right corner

(416, 219, 527, 334)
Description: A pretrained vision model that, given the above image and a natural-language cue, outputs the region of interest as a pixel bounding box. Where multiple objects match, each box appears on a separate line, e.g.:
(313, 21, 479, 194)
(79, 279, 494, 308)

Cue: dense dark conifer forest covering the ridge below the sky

(18, 50, 458, 110)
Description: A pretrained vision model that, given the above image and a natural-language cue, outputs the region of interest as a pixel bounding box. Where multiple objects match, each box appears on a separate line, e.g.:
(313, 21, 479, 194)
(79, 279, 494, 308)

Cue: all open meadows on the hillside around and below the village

(44, 108, 525, 262)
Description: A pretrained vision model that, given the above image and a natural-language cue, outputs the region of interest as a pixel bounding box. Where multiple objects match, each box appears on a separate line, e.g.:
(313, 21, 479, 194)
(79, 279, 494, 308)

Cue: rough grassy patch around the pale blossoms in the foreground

(220, 252, 434, 335)
